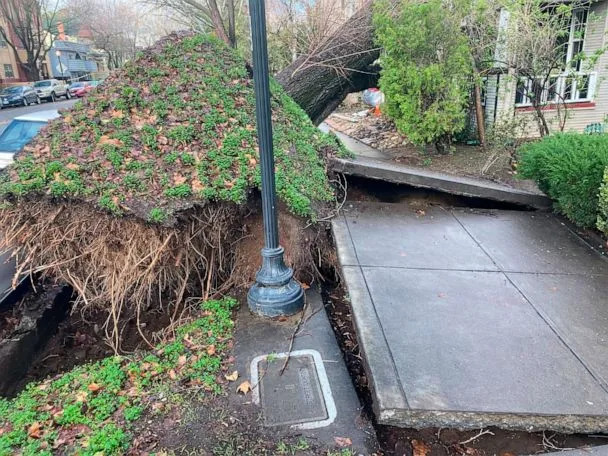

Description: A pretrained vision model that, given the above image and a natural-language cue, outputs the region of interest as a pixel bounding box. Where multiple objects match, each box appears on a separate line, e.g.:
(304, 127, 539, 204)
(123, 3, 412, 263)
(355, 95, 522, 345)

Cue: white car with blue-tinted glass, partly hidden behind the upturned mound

(0, 109, 59, 169)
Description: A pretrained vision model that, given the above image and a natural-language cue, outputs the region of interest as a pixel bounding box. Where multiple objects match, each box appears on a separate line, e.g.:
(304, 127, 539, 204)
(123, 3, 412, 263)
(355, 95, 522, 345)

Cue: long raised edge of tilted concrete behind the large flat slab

(331, 157, 553, 210)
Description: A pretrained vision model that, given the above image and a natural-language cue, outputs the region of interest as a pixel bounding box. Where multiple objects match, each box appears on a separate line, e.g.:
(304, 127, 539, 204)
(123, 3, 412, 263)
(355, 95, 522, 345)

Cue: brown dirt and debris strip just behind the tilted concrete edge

(326, 112, 538, 191)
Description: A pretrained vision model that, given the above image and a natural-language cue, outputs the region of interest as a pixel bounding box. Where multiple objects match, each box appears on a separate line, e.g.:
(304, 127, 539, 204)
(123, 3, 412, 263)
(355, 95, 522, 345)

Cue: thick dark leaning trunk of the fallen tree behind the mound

(276, 1, 380, 125)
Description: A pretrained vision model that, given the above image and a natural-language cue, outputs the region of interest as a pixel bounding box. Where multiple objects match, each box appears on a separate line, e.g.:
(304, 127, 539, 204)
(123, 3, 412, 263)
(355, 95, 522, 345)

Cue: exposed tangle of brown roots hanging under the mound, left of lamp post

(0, 201, 242, 349)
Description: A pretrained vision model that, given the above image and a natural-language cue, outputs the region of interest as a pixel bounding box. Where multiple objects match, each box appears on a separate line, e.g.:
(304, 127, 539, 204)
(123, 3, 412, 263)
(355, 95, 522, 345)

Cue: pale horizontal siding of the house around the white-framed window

(496, 0, 608, 137)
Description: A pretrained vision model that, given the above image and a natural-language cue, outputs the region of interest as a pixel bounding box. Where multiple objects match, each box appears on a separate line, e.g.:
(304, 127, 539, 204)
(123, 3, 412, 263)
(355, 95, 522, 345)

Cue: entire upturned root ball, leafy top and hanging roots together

(0, 34, 339, 350)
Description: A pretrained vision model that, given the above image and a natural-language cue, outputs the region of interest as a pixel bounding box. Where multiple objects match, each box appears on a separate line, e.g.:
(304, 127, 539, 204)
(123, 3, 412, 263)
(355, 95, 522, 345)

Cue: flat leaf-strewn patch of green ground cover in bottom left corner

(0, 298, 236, 456)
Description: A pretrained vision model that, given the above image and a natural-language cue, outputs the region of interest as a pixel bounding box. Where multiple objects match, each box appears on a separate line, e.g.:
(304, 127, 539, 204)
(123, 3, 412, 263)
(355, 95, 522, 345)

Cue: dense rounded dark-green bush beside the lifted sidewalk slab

(519, 133, 608, 227)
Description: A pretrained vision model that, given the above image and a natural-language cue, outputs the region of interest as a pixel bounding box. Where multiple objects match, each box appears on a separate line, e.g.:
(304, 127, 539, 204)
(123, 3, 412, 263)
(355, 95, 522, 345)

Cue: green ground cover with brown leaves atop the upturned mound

(0, 35, 340, 223)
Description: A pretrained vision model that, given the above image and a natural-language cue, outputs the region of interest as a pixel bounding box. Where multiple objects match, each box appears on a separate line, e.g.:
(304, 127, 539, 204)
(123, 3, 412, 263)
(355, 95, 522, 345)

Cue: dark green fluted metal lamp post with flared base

(247, 0, 304, 317)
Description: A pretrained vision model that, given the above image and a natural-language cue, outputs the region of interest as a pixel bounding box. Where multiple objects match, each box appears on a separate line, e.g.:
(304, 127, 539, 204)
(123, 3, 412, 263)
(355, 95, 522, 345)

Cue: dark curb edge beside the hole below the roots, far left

(0, 286, 73, 397)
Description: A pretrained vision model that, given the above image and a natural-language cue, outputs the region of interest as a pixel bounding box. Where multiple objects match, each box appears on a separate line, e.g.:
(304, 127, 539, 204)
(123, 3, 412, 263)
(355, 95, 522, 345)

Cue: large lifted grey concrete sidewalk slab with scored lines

(333, 203, 608, 432)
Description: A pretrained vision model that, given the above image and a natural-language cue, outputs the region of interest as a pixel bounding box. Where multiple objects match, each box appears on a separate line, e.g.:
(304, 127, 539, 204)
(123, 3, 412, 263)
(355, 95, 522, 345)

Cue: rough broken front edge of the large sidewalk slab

(375, 407, 608, 434)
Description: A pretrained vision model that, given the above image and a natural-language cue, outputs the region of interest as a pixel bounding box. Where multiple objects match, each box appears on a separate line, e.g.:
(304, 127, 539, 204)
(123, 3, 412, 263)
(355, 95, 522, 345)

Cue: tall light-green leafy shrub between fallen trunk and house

(374, 0, 472, 153)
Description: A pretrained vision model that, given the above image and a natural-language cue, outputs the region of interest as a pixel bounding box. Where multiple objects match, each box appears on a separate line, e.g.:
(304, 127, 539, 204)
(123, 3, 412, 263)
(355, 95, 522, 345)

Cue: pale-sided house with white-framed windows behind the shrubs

(484, 0, 608, 137)
